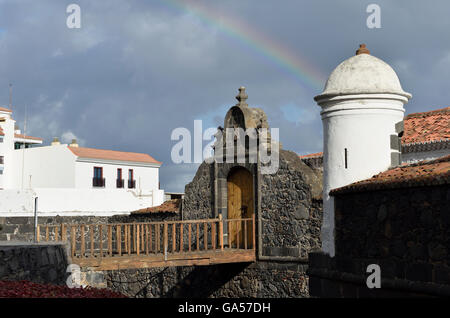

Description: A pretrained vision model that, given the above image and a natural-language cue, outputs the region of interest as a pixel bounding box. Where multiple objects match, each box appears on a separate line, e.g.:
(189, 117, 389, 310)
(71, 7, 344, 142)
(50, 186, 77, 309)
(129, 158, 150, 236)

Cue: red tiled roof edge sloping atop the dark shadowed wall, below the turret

(330, 155, 450, 195)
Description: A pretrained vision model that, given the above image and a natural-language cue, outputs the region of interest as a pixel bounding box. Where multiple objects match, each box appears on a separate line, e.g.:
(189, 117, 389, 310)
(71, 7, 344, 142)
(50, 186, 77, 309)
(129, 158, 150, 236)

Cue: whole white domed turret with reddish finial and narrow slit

(314, 44, 411, 257)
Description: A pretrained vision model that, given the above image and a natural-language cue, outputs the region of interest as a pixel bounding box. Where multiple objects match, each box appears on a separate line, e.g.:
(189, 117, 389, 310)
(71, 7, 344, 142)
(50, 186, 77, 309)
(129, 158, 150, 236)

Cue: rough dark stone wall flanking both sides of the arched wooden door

(183, 150, 322, 258)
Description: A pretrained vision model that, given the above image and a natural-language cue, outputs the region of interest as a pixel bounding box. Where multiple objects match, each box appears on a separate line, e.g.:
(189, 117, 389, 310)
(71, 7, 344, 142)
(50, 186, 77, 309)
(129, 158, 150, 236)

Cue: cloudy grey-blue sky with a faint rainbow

(0, 0, 450, 191)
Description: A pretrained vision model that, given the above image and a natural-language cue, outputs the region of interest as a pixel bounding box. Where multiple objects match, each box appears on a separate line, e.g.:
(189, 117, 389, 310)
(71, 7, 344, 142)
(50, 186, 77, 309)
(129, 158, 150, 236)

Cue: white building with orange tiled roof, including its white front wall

(0, 108, 164, 216)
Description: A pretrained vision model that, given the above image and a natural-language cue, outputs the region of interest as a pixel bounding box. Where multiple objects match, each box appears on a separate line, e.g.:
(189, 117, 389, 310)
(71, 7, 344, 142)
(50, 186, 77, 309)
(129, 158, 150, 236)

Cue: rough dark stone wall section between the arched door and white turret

(261, 150, 322, 258)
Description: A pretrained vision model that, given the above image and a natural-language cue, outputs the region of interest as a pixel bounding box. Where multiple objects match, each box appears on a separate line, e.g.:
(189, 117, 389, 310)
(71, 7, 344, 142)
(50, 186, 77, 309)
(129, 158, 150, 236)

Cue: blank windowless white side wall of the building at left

(9, 145, 76, 189)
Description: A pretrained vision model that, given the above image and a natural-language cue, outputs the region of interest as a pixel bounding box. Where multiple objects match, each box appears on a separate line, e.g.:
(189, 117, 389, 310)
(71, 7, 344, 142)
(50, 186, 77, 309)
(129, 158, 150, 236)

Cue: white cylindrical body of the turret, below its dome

(320, 94, 407, 256)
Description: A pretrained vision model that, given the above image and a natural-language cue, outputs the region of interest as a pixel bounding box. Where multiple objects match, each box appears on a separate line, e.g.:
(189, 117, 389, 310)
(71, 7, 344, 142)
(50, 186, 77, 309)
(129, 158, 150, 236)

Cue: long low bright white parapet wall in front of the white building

(0, 188, 164, 217)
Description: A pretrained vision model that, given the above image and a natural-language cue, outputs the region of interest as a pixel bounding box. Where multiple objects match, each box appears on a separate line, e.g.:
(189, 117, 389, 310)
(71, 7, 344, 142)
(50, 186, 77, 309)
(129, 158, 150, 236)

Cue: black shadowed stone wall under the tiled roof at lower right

(310, 184, 450, 297)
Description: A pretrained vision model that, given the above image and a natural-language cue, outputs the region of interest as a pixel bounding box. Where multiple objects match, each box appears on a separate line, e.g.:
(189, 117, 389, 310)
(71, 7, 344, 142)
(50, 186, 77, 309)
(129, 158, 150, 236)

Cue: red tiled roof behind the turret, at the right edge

(402, 107, 450, 144)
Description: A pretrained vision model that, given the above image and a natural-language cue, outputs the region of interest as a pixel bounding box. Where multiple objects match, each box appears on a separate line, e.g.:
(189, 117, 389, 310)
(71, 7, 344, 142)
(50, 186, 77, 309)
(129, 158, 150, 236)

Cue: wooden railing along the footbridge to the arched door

(37, 216, 255, 258)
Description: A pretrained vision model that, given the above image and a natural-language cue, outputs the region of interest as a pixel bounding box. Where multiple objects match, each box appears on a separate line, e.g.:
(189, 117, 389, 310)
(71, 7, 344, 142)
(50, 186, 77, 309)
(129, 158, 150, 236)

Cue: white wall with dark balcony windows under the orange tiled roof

(75, 159, 159, 190)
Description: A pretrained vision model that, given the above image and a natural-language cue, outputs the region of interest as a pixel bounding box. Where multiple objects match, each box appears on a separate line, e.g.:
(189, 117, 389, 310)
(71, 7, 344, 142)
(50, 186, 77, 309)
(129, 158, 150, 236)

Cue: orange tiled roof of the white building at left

(68, 146, 161, 164)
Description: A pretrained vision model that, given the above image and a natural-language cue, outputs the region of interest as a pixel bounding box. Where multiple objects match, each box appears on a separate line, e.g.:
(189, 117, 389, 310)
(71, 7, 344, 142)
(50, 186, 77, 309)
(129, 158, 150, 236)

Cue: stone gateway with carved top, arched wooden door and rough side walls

(183, 87, 322, 261)
